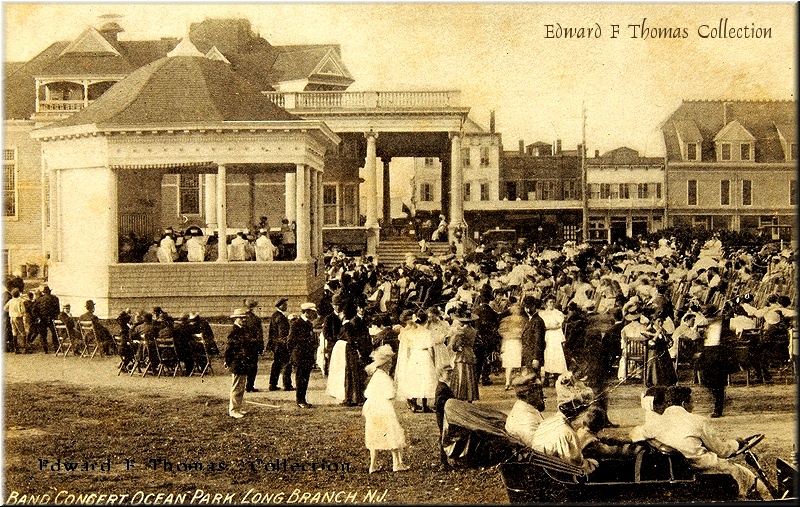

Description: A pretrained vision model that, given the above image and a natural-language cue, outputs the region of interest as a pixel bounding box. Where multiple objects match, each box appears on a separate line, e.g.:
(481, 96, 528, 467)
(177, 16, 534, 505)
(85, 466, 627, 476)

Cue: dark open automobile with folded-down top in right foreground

(442, 400, 797, 503)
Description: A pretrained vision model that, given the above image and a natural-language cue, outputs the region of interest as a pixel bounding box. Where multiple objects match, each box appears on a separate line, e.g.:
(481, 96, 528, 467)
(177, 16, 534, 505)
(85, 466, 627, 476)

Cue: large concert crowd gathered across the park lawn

(4, 231, 797, 500)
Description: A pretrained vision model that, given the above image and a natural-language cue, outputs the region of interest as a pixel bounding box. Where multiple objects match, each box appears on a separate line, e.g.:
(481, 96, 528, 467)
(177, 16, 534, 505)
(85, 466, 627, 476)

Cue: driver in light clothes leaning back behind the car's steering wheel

(631, 386, 772, 499)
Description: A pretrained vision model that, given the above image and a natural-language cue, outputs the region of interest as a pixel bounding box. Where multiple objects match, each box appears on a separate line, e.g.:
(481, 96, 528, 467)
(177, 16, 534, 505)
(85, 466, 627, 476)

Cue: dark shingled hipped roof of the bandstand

(53, 56, 298, 128)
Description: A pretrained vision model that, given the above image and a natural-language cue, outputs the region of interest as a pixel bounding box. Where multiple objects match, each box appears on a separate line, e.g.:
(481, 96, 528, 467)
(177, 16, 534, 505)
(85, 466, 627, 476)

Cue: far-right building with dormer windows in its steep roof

(661, 100, 797, 239)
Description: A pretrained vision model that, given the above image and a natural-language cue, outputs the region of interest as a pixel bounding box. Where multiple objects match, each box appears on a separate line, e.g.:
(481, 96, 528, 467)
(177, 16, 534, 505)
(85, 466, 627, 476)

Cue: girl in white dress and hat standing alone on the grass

(362, 345, 409, 473)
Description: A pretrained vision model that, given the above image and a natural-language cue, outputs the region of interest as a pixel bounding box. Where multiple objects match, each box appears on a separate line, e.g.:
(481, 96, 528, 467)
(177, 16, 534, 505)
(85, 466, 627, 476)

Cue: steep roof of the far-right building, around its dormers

(661, 100, 797, 162)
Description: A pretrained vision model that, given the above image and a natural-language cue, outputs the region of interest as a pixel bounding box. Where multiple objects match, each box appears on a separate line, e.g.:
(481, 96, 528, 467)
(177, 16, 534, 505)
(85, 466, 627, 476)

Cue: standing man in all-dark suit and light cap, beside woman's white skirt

(288, 303, 318, 408)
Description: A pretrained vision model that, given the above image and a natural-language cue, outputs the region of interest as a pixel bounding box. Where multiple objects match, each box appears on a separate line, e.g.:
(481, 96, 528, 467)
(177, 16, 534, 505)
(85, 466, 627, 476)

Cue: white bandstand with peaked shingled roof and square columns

(32, 47, 339, 317)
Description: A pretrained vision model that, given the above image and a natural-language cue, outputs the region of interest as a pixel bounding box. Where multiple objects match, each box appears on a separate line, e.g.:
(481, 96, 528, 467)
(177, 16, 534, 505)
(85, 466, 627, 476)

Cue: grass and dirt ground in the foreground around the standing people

(2, 353, 797, 504)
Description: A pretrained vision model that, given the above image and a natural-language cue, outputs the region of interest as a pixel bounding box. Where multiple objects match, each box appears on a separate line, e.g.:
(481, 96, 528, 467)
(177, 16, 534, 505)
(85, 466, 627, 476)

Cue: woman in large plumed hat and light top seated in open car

(533, 372, 598, 474)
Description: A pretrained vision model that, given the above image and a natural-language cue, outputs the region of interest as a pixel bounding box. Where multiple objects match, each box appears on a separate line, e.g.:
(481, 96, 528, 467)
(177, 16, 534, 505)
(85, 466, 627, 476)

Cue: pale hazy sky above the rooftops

(3, 2, 797, 156)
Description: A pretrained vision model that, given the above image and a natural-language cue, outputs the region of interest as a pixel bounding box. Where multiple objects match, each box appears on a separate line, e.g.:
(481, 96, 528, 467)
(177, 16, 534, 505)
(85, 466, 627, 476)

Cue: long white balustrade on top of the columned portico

(263, 91, 461, 110)
